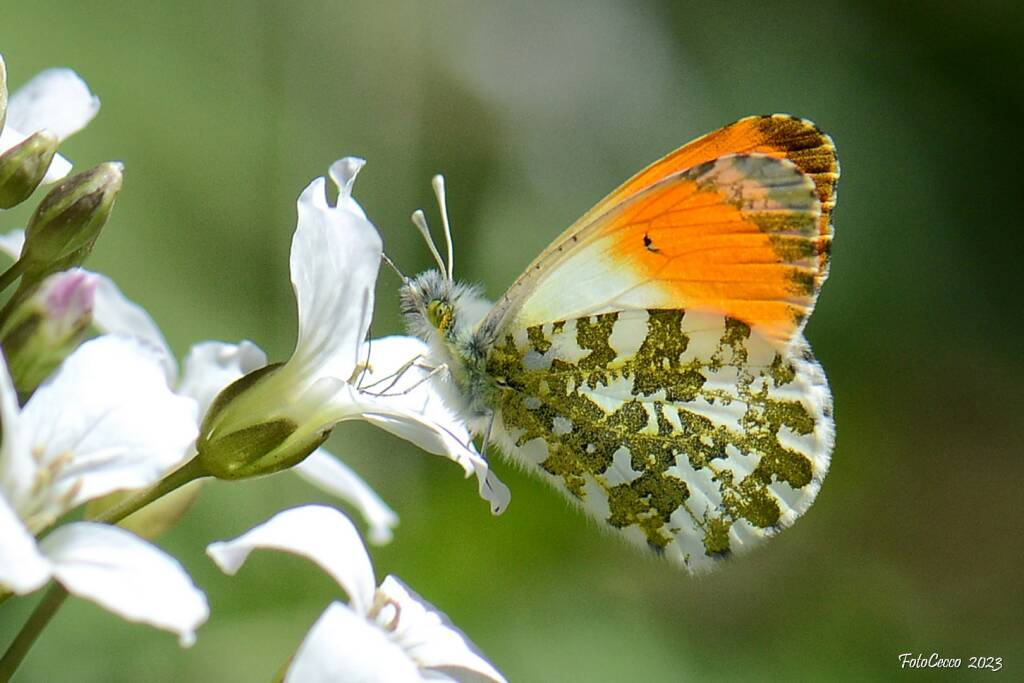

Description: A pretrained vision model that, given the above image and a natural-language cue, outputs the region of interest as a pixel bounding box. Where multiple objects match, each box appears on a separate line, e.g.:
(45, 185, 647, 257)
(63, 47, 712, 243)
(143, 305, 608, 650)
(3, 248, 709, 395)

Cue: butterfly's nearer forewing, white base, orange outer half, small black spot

(481, 154, 831, 347)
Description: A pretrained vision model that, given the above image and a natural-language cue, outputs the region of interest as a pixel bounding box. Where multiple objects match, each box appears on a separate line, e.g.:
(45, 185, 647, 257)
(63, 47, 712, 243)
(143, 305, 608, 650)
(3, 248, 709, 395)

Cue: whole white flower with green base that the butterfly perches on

(200, 158, 508, 512)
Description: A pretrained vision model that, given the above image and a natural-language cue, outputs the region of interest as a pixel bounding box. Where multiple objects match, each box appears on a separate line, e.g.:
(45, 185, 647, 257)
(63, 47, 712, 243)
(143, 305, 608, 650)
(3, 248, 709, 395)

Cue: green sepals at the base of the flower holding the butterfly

(196, 364, 331, 479)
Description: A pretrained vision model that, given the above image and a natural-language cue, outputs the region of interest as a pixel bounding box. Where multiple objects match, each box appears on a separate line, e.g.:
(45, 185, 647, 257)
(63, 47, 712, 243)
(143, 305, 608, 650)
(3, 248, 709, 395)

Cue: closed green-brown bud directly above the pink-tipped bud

(22, 162, 124, 282)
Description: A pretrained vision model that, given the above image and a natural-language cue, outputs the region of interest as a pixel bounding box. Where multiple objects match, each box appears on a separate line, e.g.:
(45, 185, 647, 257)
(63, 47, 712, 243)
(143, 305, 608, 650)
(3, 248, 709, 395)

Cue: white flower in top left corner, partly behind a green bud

(0, 65, 99, 183)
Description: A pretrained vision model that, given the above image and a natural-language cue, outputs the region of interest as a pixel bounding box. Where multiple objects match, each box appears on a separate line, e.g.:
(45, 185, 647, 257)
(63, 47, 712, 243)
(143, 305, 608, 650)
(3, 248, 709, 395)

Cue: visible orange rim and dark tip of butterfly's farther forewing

(577, 114, 839, 287)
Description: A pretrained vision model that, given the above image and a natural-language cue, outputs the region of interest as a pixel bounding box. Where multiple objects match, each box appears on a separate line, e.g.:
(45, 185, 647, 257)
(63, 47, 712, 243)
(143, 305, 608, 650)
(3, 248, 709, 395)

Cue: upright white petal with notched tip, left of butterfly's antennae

(288, 158, 382, 380)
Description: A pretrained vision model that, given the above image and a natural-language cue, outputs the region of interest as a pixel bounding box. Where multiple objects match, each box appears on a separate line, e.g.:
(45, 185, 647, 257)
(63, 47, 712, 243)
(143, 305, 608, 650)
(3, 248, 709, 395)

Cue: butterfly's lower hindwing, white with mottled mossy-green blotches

(487, 310, 834, 571)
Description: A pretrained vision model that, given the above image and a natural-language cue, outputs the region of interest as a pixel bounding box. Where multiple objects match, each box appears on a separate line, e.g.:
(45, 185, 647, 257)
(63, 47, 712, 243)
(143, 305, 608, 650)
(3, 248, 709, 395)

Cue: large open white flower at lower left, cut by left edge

(0, 335, 208, 645)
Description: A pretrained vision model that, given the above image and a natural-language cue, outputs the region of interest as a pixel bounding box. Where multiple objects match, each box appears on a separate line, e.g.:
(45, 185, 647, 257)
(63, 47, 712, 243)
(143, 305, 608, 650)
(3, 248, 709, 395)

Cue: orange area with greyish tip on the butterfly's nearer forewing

(593, 155, 823, 344)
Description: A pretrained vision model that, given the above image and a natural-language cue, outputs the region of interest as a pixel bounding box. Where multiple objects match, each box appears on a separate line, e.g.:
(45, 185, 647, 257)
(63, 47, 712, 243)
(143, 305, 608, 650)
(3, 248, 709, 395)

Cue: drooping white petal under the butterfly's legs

(357, 336, 511, 514)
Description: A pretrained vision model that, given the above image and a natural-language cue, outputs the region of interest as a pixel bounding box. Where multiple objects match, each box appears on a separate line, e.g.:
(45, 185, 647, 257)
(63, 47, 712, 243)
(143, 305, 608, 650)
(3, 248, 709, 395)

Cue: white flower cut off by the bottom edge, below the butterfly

(207, 505, 505, 683)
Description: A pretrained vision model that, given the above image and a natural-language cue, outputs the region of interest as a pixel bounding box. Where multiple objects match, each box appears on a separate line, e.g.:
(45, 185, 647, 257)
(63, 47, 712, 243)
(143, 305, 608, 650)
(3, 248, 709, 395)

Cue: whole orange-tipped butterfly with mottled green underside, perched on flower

(399, 115, 839, 572)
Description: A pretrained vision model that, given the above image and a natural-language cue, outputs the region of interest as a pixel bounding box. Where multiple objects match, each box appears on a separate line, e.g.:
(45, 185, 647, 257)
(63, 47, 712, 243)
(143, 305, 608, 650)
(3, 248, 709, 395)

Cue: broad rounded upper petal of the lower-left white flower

(22, 335, 198, 514)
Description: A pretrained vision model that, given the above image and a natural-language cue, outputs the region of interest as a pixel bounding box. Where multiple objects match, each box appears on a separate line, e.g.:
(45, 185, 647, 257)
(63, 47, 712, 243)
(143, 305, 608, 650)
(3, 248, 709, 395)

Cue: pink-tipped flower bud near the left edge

(0, 270, 97, 396)
